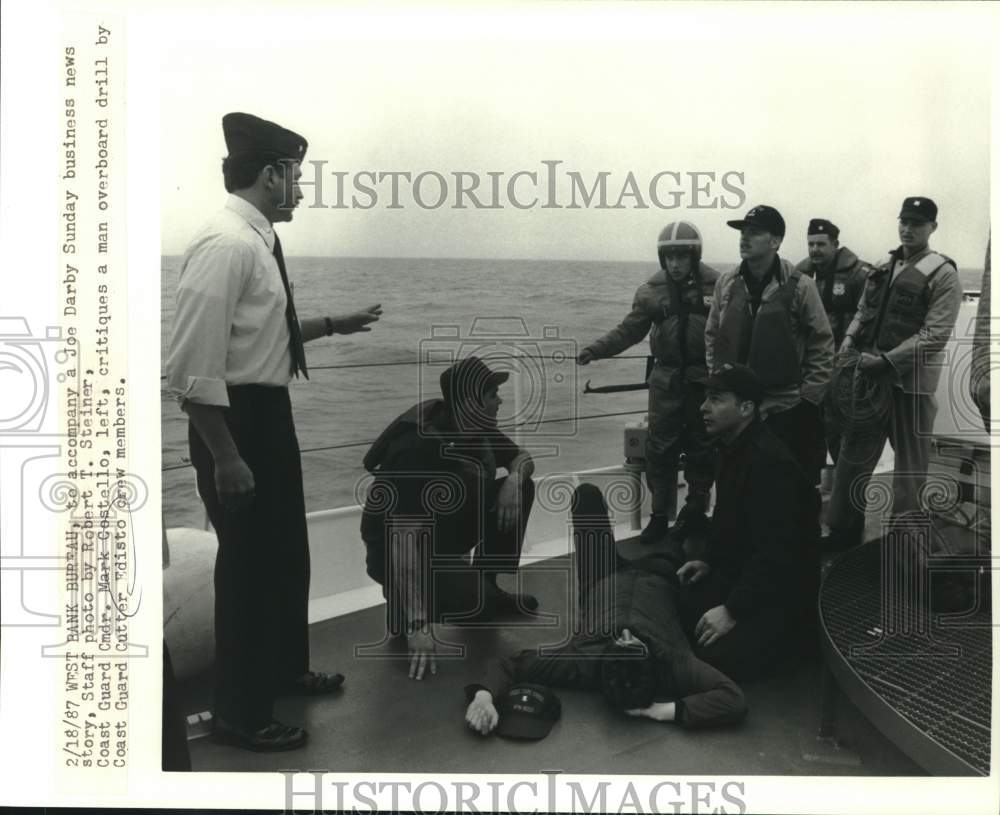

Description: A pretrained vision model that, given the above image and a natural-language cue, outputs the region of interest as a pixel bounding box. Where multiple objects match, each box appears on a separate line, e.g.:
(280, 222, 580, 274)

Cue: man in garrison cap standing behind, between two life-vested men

(795, 218, 872, 464)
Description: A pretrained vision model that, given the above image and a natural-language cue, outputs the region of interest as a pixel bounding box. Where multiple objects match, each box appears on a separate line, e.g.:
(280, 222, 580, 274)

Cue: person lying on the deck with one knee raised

(465, 484, 747, 735)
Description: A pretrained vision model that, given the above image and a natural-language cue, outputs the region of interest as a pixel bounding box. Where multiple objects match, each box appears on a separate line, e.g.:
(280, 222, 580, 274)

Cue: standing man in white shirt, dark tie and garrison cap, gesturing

(166, 113, 381, 751)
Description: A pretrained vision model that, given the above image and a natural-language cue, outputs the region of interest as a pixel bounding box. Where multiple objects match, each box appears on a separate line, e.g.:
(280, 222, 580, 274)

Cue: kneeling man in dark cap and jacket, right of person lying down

(677, 363, 819, 681)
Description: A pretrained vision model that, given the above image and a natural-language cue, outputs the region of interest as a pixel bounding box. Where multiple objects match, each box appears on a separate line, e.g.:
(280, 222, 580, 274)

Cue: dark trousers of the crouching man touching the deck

(383, 476, 535, 634)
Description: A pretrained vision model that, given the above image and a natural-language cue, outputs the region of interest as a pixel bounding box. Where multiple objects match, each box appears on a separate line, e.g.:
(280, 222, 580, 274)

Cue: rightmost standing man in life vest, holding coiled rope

(828, 196, 962, 547)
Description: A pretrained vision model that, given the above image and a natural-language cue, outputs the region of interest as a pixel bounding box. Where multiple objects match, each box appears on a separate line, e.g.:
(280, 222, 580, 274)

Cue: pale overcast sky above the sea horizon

(160, 4, 991, 266)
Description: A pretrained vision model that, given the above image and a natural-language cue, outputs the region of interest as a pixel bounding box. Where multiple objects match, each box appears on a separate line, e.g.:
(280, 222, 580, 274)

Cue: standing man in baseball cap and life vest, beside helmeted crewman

(705, 204, 833, 484)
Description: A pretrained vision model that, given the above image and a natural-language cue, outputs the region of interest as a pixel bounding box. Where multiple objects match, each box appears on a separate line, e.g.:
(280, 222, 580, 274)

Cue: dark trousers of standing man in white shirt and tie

(188, 385, 309, 728)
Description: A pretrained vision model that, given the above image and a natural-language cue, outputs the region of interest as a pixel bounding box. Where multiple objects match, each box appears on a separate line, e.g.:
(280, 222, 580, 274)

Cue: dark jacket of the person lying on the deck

(494, 558, 747, 728)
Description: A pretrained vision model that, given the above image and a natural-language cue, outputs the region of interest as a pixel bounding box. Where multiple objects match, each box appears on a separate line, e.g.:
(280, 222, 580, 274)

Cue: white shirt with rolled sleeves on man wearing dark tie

(166, 195, 292, 407)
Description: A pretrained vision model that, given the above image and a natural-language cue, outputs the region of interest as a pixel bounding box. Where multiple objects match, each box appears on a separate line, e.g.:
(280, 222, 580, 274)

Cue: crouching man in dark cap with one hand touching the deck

(361, 357, 538, 679)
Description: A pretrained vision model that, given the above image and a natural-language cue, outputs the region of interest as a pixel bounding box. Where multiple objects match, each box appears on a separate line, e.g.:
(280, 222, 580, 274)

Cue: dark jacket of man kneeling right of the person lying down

(706, 419, 819, 620)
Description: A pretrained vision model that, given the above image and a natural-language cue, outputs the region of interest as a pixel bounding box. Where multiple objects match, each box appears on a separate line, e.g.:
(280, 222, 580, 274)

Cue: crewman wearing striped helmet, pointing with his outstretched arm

(577, 221, 719, 544)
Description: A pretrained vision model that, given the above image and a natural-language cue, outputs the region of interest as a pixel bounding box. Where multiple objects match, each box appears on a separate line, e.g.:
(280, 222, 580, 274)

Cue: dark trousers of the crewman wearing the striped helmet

(646, 366, 714, 515)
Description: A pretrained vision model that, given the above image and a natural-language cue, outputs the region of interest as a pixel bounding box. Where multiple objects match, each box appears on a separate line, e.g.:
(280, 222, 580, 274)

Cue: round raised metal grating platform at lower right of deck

(820, 542, 993, 775)
